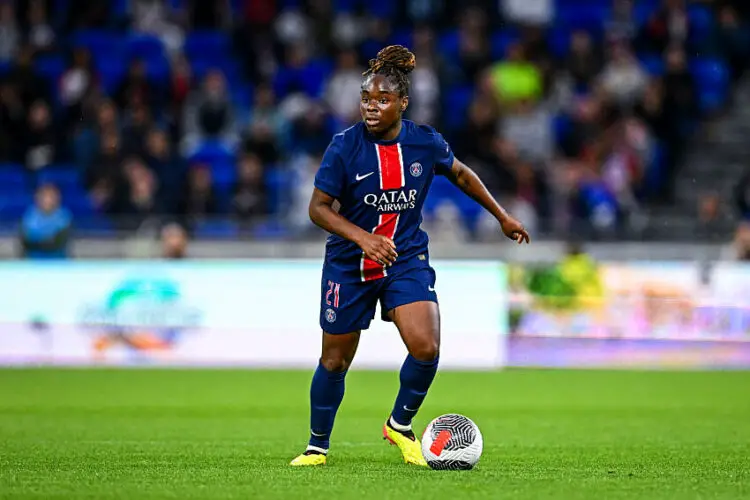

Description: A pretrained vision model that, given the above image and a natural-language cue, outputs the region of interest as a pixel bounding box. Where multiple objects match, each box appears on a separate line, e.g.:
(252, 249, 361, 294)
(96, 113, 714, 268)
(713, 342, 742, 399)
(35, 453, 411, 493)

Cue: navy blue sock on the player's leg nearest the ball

(391, 354, 438, 427)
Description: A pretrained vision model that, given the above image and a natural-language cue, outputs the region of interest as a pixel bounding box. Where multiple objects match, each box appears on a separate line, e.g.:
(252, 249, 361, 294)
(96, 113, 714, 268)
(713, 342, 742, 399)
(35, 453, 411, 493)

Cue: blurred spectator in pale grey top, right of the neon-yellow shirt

(599, 44, 648, 108)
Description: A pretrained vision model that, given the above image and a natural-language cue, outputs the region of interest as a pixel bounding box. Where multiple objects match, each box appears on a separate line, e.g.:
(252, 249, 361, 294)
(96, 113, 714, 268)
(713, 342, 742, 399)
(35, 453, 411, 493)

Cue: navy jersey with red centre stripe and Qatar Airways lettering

(315, 120, 453, 283)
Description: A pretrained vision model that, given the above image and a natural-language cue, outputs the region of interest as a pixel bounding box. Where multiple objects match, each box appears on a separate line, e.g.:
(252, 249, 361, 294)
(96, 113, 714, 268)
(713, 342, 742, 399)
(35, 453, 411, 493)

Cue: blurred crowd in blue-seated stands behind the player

(0, 0, 750, 258)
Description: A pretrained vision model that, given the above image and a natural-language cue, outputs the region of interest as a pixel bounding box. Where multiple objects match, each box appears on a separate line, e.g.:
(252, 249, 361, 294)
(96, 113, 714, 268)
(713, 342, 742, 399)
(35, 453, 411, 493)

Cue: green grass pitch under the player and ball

(0, 369, 750, 500)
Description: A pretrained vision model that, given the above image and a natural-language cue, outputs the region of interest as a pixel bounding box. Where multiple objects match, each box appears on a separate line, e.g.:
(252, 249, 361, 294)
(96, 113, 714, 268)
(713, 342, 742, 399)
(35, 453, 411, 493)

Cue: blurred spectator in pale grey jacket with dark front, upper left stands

(183, 70, 238, 149)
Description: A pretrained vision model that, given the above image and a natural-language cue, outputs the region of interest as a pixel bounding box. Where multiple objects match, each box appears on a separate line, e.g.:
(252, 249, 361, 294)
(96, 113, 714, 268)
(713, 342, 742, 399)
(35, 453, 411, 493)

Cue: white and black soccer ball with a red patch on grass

(422, 413, 484, 470)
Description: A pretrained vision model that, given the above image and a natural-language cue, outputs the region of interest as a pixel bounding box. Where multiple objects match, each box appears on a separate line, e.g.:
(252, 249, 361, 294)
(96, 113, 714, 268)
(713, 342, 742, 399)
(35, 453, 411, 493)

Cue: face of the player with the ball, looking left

(359, 75, 409, 135)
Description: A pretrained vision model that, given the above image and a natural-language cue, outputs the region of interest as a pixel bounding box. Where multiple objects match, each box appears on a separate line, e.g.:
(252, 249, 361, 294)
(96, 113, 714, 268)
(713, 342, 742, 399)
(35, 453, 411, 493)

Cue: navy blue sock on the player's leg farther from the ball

(309, 363, 346, 450)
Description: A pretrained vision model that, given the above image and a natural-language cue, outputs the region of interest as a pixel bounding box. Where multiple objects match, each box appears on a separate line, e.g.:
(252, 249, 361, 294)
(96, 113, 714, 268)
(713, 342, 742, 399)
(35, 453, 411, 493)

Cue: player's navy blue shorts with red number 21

(320, 265, 437, 334)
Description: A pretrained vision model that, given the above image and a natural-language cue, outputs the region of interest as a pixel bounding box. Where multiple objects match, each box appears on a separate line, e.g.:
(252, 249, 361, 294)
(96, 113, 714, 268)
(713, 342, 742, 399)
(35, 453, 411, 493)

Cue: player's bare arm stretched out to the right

(444, 158, 531, 244)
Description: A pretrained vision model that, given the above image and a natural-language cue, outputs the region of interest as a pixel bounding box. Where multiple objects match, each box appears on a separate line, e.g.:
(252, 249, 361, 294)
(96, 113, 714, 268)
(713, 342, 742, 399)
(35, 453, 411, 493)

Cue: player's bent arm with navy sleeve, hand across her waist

(308, 139, 398, 265)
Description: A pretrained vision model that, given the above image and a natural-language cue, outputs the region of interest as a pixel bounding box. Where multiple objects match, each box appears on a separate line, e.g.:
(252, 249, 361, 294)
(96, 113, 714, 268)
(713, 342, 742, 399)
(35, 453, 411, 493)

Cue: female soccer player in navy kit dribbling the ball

(291, 45, 529, 466)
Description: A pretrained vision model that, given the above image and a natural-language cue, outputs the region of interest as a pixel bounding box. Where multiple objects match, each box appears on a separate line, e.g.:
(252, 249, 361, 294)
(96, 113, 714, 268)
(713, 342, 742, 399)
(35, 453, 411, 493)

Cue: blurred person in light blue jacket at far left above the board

(20, 184, 71, 259)
